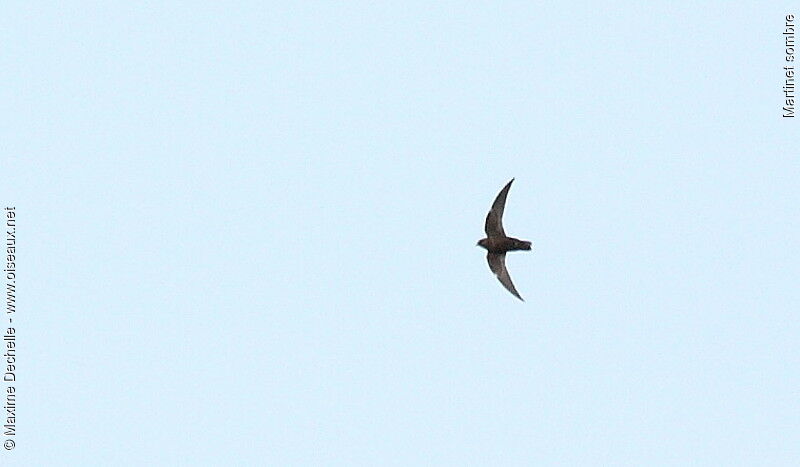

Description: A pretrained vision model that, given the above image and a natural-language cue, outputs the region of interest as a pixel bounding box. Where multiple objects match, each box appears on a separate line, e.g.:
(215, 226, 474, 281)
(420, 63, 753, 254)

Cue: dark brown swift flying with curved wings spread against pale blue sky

(478, 178, 531, 302)
